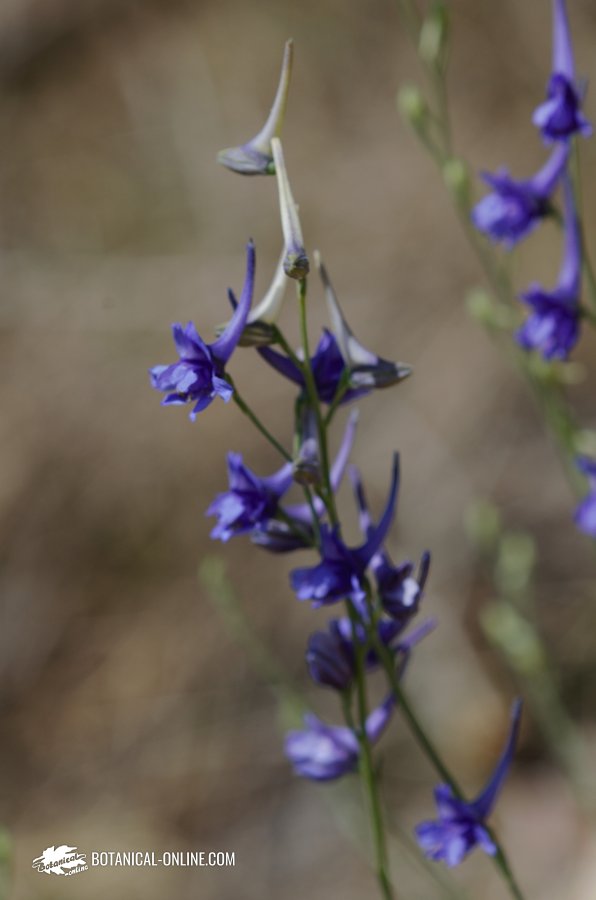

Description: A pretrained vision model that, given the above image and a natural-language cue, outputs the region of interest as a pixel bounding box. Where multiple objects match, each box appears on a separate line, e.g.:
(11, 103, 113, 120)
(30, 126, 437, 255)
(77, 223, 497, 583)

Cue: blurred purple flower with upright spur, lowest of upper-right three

(516, 175, 581, 359)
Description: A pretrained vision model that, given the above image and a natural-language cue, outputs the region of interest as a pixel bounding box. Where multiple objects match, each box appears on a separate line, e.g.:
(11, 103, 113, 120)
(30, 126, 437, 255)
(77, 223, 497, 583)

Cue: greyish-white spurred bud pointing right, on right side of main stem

(314, 250, 412, 388)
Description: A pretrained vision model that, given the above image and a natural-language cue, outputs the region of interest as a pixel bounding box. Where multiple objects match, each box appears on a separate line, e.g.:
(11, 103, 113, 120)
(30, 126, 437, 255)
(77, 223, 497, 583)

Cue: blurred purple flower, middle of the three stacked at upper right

(471, 145, 569, 248)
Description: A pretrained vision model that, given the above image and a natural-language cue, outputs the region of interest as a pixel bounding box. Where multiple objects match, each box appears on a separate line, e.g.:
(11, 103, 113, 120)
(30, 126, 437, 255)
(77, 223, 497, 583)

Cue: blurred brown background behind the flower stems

(0, 0, 596, 900)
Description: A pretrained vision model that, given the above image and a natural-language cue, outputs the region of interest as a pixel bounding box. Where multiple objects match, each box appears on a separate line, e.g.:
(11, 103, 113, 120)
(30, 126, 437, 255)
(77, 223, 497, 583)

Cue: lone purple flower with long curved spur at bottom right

(416, 700, 522, 866)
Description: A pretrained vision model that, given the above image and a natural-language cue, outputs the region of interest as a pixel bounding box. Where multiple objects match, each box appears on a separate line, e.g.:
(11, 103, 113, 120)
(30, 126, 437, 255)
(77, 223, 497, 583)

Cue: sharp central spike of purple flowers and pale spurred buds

(150, 42, 520, 880)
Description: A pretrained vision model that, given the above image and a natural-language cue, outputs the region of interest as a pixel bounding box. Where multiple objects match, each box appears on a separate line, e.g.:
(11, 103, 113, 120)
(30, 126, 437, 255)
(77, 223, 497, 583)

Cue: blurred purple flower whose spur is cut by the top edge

(532, 0, 592, 143)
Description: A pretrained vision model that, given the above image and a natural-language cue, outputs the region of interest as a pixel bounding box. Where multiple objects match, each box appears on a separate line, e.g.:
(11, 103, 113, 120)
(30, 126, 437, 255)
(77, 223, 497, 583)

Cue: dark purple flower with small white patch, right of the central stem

(350, 466, 430, 628)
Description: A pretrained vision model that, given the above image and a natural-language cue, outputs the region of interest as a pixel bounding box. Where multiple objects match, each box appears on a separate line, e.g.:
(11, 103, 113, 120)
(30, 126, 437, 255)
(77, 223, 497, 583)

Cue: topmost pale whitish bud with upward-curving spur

(217, 40, 294, 175)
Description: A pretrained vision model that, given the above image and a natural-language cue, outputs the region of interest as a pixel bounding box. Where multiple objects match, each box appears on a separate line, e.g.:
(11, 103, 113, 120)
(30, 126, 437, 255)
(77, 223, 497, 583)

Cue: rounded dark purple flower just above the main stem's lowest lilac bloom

(306, 616, 435, 691)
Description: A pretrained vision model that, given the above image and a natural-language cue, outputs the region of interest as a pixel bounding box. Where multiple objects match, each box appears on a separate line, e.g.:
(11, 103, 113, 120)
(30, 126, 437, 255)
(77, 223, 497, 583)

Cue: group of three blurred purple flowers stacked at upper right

(472, 0, 592, 360)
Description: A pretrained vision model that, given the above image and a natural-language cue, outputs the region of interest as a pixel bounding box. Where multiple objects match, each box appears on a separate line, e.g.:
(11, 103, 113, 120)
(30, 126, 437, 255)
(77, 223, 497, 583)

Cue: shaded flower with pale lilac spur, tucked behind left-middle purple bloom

(250, 412, 358, 553)
